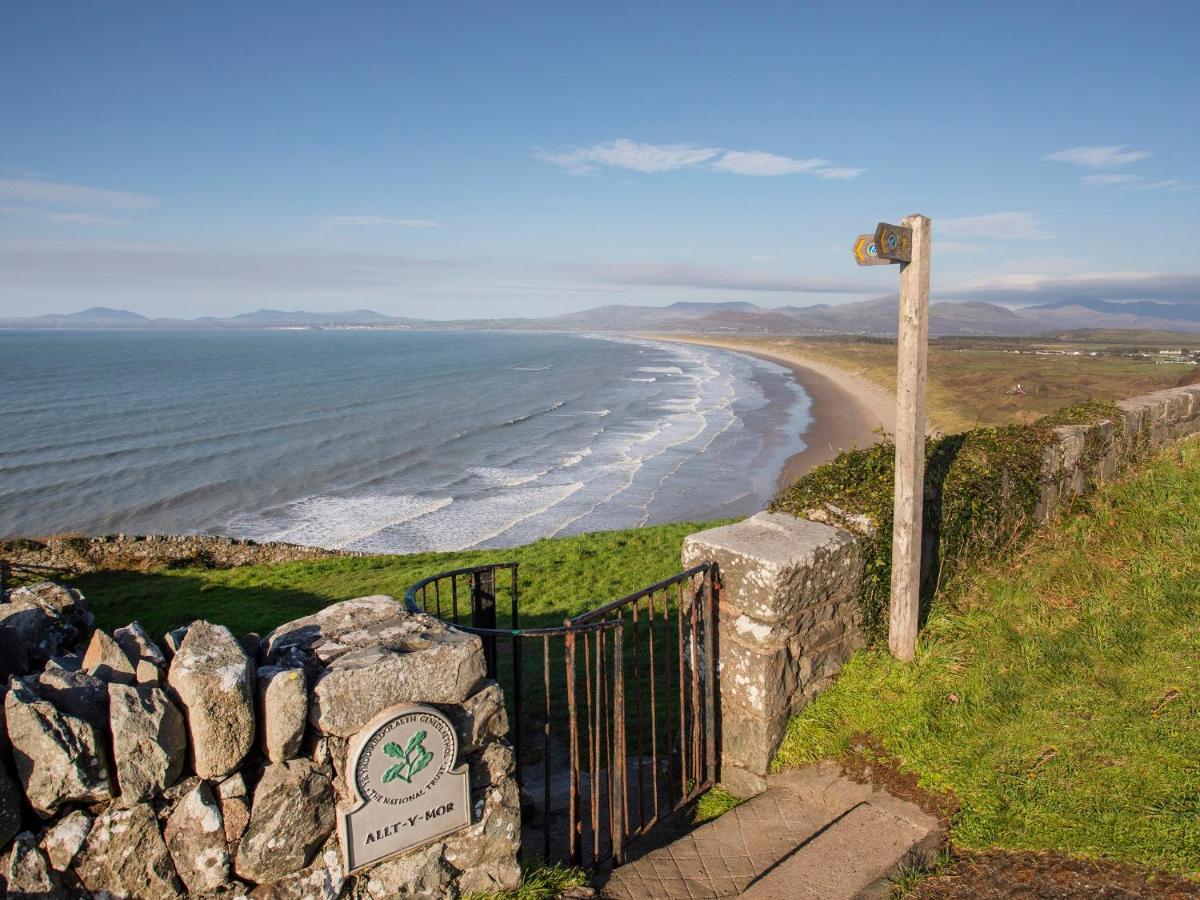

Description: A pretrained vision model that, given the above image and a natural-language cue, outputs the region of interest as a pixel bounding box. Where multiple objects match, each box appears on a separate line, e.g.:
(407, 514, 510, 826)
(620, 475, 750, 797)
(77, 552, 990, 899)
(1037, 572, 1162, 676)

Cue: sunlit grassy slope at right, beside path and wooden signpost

(776, 440, 1200, 874)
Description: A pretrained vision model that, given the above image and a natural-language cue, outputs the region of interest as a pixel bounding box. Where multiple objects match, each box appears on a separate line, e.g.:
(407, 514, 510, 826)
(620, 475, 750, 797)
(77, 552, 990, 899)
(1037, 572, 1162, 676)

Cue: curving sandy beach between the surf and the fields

(647, 335, 896, 488)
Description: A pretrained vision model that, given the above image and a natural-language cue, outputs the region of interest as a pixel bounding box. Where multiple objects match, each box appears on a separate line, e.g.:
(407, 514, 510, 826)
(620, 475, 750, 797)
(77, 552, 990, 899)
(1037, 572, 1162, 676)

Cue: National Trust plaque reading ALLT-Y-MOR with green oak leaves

(337, 706, 470, 874)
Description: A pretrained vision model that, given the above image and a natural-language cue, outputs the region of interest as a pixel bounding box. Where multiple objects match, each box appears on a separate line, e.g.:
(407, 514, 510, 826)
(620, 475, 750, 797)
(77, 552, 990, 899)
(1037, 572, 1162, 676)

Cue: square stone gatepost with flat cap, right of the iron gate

(683, 512, 865, 797)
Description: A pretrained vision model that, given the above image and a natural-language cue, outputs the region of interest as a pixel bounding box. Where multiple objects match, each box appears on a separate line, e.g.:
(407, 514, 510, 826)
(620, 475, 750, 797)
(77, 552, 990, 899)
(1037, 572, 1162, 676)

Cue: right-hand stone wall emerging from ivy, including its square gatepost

(683, 385, 1200, 797)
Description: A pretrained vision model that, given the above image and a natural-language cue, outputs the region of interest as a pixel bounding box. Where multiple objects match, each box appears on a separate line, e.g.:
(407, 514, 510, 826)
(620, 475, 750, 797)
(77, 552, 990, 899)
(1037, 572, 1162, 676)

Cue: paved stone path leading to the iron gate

(600, 763, 944, 900)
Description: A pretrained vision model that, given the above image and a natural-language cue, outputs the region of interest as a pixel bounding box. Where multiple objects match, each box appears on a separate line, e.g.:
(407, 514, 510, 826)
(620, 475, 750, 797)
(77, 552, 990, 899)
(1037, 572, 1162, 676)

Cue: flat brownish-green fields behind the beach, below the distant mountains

(700, 335, 1190, 432)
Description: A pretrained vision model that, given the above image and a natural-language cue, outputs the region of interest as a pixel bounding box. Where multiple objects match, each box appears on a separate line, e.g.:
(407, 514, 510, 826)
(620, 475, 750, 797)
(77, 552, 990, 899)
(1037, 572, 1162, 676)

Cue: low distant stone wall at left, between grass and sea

(0, 534, 366, 572)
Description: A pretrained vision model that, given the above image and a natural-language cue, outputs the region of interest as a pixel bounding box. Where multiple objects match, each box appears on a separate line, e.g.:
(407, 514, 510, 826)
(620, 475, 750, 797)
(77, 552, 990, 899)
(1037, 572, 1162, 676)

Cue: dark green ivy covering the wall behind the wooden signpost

(768, 401, 1136, 640)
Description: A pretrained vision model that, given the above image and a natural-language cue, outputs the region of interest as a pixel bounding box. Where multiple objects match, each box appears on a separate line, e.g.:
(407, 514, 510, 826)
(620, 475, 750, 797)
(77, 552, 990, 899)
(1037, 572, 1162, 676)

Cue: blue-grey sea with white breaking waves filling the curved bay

(0, 330, 809, 553)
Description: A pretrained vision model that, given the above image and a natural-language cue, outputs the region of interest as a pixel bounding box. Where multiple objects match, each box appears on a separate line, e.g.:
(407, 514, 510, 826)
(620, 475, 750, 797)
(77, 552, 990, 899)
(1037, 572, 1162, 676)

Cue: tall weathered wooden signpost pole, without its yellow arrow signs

(888, 216, 932, 661)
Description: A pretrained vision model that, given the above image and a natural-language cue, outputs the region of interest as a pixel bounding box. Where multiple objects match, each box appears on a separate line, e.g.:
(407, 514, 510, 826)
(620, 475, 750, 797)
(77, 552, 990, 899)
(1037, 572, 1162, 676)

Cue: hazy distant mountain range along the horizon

(7, 295, 1200, 337)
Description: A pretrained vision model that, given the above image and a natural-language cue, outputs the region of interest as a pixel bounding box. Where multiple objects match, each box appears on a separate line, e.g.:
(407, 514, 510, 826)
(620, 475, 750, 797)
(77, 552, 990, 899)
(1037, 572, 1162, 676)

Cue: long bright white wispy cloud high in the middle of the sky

(535, 138, 865, 179)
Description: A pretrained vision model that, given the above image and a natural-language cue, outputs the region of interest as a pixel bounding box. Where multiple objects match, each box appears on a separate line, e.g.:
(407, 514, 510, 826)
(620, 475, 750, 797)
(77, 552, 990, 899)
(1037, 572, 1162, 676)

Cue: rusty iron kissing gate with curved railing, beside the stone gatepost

(404, 563, 719, 869)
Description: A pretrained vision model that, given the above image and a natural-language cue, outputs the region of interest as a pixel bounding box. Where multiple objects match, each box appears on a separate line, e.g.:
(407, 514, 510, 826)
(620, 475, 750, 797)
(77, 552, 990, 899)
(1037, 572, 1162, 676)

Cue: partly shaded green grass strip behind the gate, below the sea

(72, 523, 734, 635)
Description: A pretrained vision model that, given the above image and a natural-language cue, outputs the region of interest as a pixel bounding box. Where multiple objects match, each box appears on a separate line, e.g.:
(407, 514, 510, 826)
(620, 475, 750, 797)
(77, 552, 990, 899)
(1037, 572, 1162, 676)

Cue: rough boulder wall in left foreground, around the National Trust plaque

(0, 582, 521, 899)
